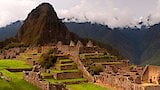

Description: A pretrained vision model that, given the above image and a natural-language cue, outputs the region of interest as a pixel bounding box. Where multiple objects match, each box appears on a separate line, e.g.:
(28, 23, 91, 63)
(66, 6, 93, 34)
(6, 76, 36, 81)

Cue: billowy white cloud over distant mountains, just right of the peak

(58, 0, 139, 27)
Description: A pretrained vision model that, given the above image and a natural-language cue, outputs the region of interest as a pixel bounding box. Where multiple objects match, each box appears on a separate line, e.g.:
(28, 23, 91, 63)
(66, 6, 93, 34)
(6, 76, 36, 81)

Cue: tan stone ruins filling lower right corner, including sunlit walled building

(95, 65, 160, 90)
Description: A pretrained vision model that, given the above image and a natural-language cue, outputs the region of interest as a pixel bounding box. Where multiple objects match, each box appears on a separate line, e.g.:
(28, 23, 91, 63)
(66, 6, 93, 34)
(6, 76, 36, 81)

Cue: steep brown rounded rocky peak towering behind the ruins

(17, 3, 79, 45)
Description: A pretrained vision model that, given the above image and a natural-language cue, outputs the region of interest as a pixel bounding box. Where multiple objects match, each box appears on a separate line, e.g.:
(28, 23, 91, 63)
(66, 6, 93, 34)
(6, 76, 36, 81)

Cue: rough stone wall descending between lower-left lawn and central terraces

(23, 64, 67, 90)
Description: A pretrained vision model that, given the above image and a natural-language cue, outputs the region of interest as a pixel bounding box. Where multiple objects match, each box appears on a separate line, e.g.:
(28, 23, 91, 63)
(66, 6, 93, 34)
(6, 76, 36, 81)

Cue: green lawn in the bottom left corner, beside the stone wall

(0, 69, 38, 90)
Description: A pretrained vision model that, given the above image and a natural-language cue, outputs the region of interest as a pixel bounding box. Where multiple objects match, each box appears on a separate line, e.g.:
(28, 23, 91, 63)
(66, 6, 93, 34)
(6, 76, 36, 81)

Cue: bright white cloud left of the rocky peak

(0, 0, 36, 26)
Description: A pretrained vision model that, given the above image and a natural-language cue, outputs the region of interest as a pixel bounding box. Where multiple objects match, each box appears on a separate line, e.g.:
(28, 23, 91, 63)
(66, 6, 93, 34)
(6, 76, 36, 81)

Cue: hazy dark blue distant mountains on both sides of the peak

(0, 22, 160, 65)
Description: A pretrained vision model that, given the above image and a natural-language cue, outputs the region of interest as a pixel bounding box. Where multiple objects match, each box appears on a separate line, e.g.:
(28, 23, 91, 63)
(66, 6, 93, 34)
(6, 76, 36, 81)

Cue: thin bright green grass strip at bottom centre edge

(67, 83, 111, 90)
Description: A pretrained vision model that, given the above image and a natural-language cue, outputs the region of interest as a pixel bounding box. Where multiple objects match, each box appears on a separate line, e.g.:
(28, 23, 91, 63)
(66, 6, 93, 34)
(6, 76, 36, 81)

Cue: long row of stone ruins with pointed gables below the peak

(0, 41, 102, 59)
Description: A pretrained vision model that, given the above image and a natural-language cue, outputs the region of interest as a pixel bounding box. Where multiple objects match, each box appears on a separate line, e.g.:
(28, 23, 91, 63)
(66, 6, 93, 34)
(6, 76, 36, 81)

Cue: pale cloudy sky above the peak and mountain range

(0, 0, 160, 27)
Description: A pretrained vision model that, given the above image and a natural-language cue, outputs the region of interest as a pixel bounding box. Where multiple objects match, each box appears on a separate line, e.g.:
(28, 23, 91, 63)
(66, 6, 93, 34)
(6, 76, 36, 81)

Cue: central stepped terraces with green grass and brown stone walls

(42, 59, 87, 84)
